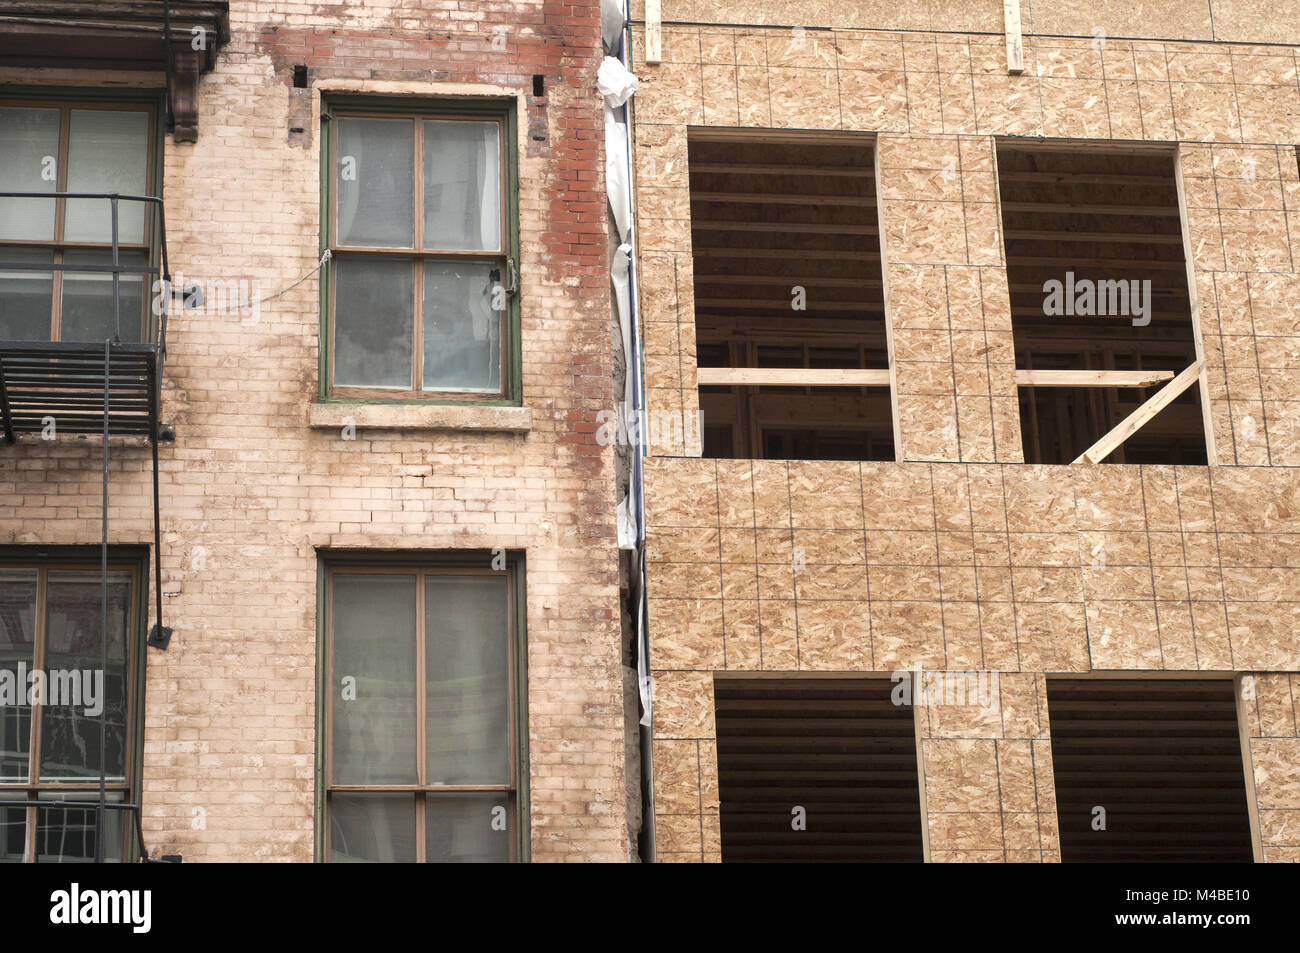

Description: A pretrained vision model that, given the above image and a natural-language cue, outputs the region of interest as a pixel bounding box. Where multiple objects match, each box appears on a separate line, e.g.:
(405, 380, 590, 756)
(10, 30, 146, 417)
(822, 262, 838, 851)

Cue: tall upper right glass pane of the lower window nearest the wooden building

(424, 573, 510, 784)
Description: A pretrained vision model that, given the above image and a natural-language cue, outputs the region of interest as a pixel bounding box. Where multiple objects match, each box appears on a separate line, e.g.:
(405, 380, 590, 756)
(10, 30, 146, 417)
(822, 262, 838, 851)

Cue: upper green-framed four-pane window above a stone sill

(321, 98, 519, 403)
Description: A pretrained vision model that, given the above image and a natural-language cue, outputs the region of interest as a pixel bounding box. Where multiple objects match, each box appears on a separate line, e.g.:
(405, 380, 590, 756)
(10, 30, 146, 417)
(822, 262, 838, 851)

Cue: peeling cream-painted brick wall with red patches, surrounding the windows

(0, 0, 629, 862)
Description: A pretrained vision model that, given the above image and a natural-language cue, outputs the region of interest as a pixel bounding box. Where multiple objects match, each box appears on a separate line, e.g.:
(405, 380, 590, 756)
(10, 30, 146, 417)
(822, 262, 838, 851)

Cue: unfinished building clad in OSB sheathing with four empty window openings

(633, 0, 1300, 862)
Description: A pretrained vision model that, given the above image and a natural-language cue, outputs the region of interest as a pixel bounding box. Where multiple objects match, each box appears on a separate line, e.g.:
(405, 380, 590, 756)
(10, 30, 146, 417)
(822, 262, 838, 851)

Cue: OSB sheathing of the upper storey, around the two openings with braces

(634, 26, 1300, 465)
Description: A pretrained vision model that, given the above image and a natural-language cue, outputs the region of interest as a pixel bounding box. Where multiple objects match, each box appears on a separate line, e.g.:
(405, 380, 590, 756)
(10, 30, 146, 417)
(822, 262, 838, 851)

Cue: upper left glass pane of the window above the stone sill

(334, 117, 415, 248)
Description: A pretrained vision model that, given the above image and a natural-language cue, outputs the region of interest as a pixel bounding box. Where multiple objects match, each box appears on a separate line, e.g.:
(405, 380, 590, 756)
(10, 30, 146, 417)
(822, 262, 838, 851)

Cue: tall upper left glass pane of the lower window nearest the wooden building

(330, 575, 416, 784)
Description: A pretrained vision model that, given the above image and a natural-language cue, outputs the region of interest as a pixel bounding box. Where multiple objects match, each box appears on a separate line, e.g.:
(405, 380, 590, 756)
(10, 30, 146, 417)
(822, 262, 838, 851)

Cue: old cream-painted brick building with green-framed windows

(0, 0, 636, 862)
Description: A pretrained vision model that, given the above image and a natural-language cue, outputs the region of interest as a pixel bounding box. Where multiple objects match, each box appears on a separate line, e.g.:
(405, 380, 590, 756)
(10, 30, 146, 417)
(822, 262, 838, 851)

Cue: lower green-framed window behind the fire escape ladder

(0, 551, 146, 863)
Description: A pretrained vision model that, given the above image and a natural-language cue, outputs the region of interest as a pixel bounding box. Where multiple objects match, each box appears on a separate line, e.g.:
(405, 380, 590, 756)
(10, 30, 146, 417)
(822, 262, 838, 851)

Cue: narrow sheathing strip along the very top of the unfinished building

(632, 0, 1300, 43)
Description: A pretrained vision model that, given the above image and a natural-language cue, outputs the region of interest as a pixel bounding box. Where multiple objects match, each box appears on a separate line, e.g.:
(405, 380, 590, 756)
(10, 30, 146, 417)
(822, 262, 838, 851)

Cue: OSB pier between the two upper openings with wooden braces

(878, 134, 1023, 462)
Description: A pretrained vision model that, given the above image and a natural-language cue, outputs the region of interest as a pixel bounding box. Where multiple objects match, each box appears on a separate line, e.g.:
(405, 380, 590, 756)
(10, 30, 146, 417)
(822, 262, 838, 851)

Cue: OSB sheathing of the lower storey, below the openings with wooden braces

(646, 459, 1300, 861)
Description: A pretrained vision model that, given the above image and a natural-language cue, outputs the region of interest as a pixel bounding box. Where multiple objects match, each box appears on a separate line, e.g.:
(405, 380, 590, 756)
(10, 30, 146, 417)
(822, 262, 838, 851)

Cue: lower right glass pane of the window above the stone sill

(421, 261, 506, 394)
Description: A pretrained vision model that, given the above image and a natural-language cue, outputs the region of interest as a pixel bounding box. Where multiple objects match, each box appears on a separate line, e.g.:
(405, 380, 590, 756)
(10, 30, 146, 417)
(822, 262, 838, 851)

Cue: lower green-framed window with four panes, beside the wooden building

(319, 558, 528, 863)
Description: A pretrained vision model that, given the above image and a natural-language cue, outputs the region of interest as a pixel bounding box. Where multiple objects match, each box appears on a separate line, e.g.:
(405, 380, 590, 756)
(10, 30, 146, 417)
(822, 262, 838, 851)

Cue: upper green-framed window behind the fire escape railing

(0, 90, 160, 342)
